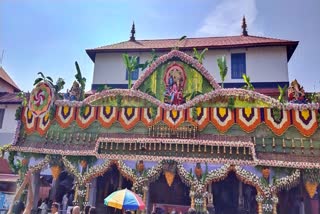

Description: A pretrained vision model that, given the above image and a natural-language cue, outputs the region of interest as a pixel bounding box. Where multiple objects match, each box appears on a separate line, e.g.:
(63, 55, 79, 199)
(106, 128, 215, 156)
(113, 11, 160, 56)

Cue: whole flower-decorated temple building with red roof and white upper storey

(4, 19, 320, 214)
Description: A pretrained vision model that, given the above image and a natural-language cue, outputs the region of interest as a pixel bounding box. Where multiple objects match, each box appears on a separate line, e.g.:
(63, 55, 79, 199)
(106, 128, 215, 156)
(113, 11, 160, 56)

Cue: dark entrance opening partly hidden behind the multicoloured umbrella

(96, 165, 132, 214)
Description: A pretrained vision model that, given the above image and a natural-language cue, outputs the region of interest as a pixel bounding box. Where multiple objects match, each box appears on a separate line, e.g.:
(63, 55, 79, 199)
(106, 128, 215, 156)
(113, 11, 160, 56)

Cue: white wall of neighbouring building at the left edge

(0, 104, 19, 145)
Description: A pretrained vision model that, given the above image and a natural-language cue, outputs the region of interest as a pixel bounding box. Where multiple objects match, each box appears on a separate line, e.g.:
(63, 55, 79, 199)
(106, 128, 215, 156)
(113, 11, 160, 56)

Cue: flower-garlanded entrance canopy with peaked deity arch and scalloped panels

(3, 50, 320, 213)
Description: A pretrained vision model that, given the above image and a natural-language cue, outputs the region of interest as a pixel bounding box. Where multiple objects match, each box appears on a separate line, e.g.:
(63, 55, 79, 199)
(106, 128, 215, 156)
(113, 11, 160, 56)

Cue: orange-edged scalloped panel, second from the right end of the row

(264, 108, 291, 136)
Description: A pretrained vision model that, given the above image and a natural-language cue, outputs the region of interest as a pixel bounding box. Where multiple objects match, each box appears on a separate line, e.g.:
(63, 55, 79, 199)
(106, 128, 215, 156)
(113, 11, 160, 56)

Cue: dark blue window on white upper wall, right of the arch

(231, 53, 246, 79)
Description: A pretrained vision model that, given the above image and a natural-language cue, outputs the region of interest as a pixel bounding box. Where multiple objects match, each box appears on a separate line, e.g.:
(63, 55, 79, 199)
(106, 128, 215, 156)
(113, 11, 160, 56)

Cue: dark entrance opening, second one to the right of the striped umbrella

(212, 172, 257, 214)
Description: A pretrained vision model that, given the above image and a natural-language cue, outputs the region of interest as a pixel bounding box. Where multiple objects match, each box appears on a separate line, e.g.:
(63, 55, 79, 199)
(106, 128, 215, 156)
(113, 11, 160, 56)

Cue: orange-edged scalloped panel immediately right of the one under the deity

(187, 107, 210, 130)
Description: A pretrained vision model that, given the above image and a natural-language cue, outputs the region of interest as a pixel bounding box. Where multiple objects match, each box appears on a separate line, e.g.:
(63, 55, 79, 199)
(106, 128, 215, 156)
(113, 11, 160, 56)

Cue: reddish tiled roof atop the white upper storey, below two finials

(86, 36, 299, 61)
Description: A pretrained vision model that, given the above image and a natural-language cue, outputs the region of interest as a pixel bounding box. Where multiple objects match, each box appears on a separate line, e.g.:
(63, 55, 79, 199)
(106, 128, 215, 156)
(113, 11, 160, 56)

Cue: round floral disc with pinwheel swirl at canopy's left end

(28, 82, 54, 117)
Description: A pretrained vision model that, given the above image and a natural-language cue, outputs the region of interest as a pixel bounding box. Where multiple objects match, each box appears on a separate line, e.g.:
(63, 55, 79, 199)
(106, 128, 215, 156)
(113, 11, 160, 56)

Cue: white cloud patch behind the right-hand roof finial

(196, 0, 263, 36)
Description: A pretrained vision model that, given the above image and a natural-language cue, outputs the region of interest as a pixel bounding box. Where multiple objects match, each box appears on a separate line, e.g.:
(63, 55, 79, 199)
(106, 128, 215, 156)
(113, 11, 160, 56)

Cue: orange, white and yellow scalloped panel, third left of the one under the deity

(98, 106, 118, 128)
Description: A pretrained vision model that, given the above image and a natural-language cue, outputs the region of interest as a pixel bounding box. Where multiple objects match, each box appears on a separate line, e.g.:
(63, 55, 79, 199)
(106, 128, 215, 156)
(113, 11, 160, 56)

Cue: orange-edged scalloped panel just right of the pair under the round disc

(56, 106, 76, 128)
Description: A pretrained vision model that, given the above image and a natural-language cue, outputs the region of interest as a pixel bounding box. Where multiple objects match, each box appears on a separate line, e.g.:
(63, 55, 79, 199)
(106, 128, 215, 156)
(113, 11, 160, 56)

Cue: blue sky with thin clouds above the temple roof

(0, 0, 320, 91)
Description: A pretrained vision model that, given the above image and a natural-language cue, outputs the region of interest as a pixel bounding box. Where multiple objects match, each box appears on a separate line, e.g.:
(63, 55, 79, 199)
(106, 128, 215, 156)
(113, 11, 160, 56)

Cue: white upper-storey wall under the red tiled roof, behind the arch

(93, 47, 289, 84)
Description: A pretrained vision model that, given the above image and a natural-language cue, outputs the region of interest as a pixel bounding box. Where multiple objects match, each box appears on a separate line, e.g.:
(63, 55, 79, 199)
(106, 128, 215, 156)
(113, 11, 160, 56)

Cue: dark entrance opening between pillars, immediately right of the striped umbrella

(148, 173, 191, 213)
